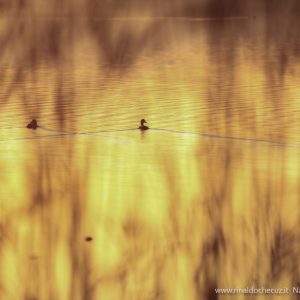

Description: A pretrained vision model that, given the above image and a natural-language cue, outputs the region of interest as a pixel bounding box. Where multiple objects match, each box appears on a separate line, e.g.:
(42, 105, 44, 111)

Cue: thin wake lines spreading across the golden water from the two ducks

(0, 126, 300, 148)
